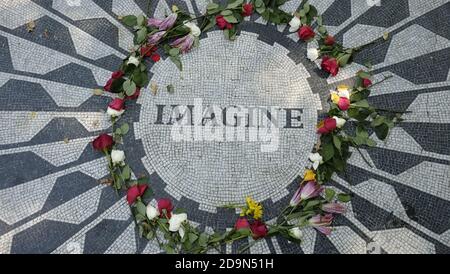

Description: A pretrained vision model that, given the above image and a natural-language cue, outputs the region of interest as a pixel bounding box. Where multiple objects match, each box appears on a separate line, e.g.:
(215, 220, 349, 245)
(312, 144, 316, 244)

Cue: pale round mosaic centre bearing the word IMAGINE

(136, 31, 320, 210)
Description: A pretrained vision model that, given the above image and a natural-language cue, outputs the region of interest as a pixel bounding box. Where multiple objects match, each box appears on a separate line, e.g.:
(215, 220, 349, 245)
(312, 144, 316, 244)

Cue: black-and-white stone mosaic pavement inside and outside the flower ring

(0, 0, 450, 254)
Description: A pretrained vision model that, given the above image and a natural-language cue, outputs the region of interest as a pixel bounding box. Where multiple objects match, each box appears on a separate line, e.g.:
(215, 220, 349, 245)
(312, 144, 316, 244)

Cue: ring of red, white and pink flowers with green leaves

(93, 0, 401, 253)
